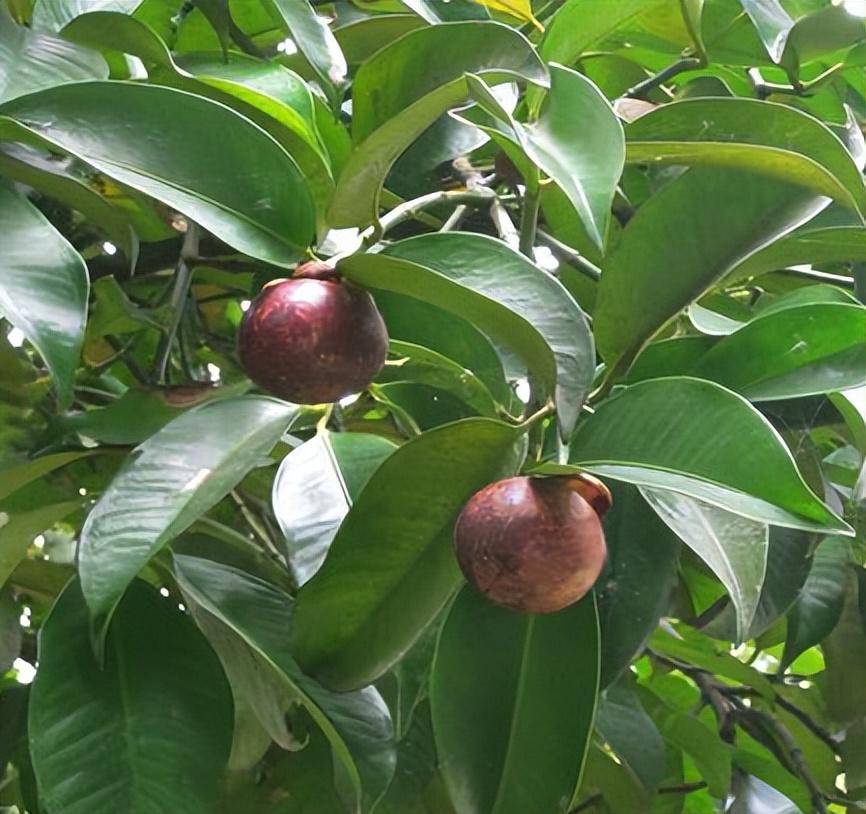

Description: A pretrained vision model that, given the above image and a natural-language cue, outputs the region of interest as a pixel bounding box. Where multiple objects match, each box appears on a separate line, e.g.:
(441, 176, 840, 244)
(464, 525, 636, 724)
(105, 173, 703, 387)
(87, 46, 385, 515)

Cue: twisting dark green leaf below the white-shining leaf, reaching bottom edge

(175, 556, 396, 812)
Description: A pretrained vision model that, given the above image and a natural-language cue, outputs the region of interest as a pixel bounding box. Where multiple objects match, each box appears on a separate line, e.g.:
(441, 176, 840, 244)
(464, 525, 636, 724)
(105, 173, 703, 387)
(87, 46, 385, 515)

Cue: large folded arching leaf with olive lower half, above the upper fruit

(328, 21, 547, 228)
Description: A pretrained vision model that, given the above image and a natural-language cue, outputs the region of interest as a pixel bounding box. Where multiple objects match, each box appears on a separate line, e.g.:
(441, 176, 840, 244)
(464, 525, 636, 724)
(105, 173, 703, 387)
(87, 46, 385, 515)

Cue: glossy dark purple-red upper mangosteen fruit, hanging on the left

(237, 261, 388, 404)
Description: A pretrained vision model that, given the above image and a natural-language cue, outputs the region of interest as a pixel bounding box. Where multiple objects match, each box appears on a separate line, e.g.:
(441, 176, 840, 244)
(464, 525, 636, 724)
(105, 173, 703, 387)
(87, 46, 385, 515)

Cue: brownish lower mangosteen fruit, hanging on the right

(454, 475, 611, 613)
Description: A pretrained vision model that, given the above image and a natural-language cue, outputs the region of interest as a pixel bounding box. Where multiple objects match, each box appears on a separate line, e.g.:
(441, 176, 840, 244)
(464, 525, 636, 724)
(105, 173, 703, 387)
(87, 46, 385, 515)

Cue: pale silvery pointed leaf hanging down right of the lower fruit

(641, 488, 769, 642)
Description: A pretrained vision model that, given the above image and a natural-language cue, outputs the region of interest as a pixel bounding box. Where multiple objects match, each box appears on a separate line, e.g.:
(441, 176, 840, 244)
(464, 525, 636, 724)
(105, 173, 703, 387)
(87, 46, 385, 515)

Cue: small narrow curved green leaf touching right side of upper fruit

(376, 339, 497, 418)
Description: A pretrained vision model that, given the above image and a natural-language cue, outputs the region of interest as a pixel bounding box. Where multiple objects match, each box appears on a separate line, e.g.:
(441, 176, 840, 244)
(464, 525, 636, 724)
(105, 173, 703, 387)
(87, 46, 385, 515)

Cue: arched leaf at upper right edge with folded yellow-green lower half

(626, 98, 866, 218)
